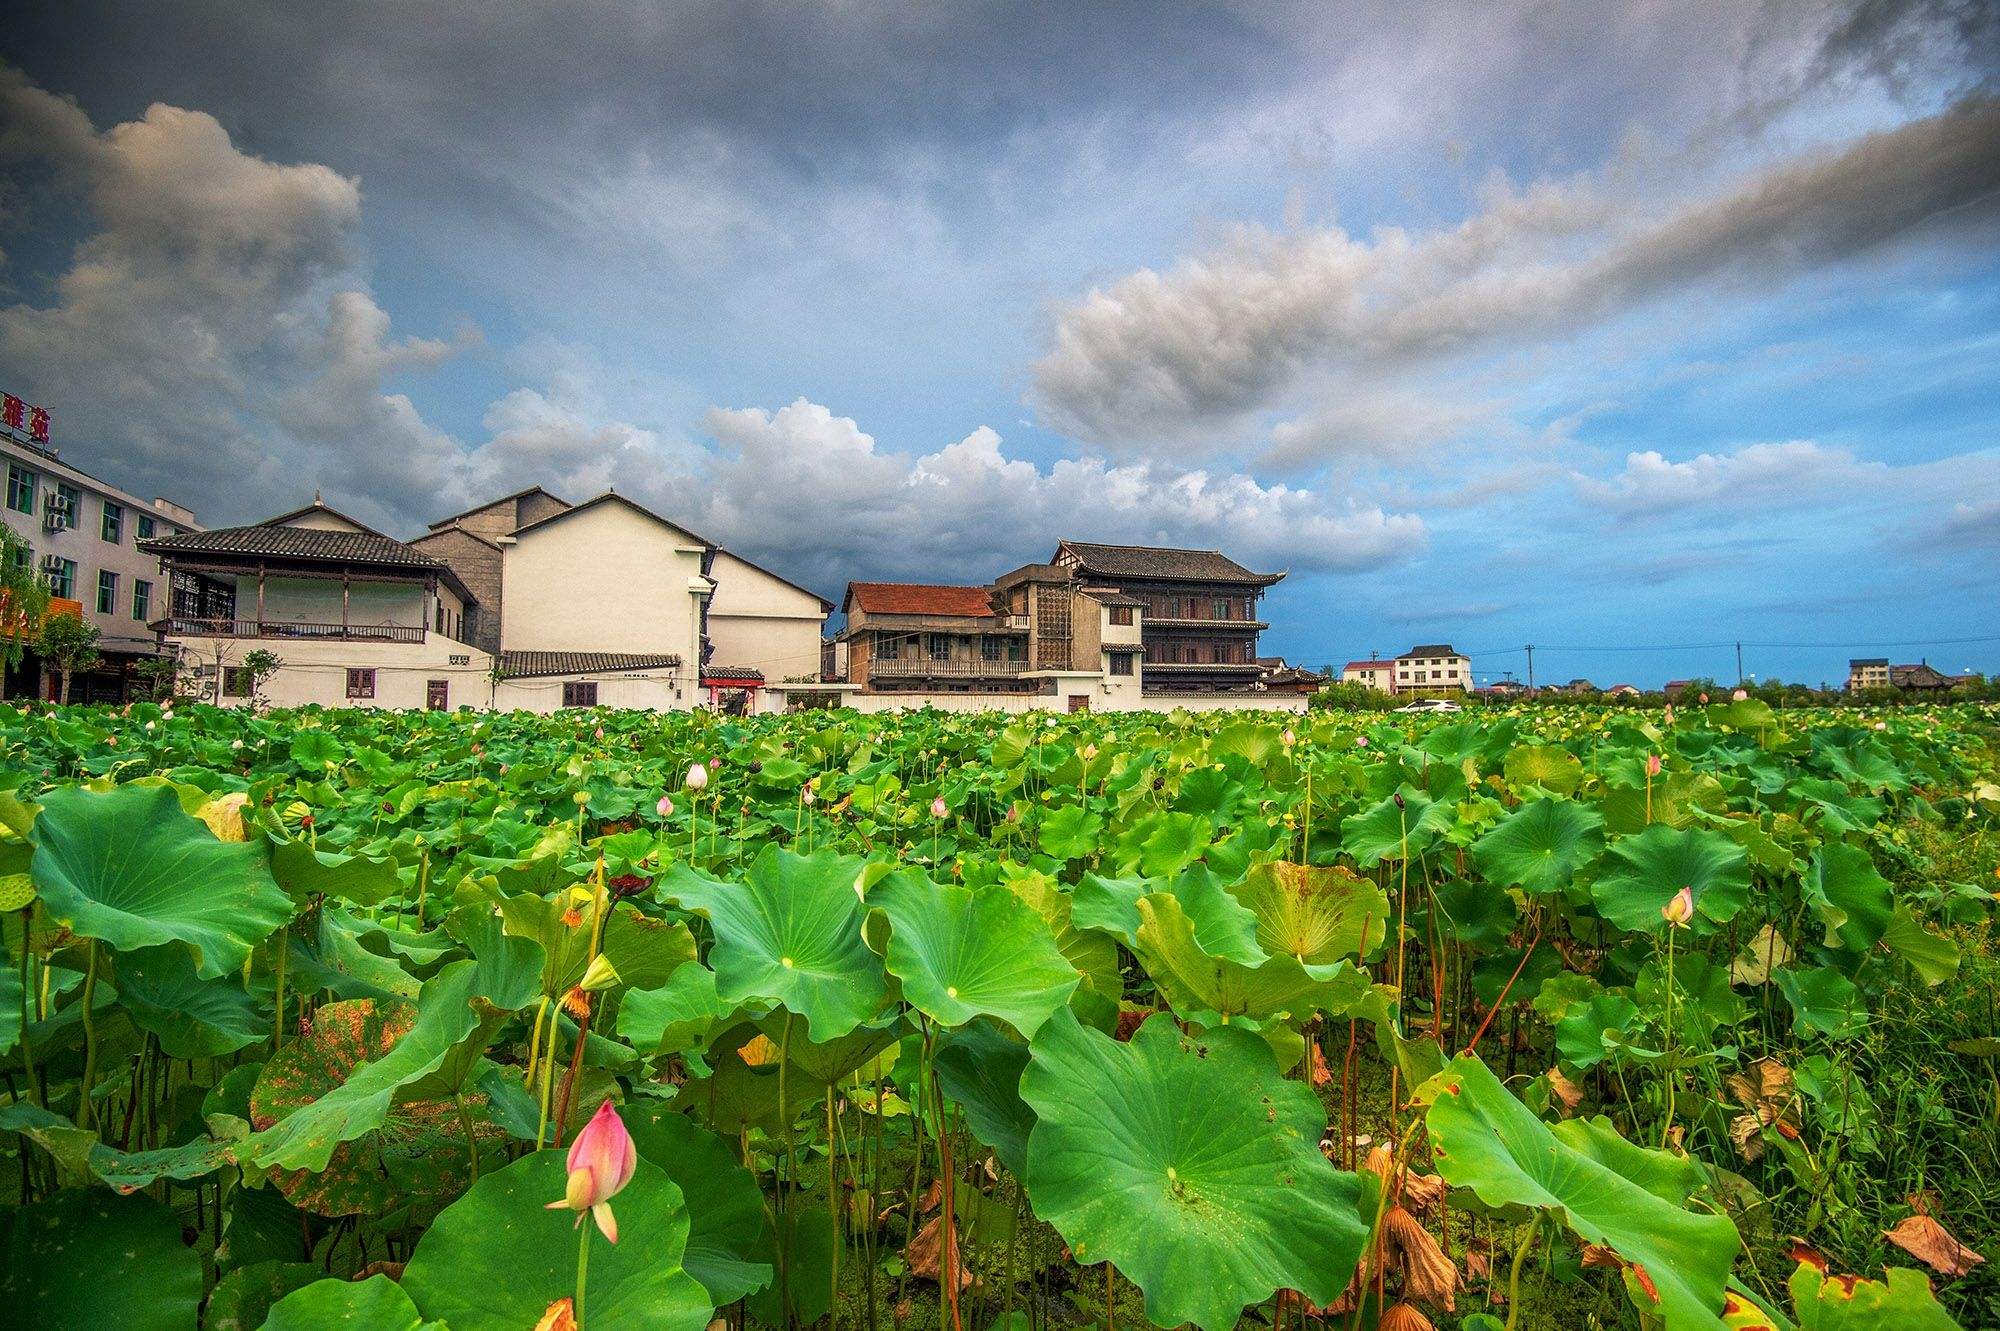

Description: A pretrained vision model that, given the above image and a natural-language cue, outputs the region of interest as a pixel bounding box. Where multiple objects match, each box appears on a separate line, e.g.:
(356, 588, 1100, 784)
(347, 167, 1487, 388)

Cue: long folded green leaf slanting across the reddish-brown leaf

(250, 949, 540, 1175)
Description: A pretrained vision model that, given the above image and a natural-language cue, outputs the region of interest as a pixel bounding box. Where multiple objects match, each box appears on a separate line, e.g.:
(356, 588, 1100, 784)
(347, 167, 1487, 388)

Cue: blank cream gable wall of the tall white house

(500, 500, 706, 681)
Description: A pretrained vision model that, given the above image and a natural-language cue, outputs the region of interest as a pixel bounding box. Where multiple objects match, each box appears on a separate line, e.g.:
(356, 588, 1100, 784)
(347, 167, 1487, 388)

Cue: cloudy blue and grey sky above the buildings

(0, 0, 2000, 685)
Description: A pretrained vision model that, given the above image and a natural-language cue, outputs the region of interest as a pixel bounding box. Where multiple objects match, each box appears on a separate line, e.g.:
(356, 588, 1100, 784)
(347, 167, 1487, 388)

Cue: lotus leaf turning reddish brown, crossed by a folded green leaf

(250, 999, 500, 1215)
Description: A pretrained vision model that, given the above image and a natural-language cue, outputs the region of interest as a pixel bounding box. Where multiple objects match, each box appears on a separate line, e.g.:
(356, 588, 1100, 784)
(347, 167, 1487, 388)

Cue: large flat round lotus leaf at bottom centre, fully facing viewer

(1020, 1011, 1368, 1331)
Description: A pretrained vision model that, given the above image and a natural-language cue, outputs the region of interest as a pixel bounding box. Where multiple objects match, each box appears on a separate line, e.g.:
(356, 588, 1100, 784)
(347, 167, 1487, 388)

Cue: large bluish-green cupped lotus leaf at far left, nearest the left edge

(32, 785, 292, 979)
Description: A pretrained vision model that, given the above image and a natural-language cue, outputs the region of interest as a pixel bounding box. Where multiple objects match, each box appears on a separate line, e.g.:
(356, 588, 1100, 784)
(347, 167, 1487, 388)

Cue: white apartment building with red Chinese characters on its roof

(0, 396, 198, 701)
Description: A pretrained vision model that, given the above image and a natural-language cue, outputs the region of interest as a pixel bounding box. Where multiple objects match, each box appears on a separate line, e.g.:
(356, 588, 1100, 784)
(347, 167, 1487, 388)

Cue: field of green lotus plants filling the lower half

(0, 699, 2000, 1331)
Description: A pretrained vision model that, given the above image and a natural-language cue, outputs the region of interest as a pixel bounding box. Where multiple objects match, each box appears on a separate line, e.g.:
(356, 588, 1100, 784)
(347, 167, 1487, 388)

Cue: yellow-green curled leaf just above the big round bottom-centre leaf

(1134, 891, 1368, 1025)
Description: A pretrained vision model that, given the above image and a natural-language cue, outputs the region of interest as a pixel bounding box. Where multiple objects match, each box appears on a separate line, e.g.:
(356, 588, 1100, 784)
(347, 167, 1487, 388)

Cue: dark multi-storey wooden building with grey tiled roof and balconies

(1050, 542, 1284, 693)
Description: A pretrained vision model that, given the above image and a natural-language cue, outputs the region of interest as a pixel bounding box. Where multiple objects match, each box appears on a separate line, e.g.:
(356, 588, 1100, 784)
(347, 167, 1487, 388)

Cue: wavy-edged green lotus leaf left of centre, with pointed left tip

(660, 843, 888, 1041)
